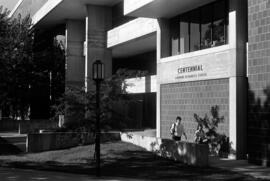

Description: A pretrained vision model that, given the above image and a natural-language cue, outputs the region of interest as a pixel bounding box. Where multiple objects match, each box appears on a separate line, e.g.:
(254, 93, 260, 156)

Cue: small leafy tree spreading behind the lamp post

(52, 69, 146, 132)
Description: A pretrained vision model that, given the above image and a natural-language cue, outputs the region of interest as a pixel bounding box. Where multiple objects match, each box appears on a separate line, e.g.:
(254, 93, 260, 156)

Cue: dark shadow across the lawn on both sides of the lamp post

(2, 147, 266, 181)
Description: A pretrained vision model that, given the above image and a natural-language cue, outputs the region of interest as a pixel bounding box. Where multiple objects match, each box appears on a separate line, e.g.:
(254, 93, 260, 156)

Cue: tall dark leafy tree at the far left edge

(0, 7, 33, 119)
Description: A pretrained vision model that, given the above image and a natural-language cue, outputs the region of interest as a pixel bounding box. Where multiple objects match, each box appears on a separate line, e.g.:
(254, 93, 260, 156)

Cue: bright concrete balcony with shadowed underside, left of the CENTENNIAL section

(107, 18, 157, 58)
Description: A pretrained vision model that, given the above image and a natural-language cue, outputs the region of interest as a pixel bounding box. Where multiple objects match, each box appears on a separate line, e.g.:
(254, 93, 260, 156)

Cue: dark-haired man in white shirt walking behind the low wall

(170, 116, 187, 141)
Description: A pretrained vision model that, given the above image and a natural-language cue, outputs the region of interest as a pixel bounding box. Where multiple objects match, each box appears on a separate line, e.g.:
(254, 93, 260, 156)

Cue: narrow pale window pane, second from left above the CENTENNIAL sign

(180, 14, 189, 54)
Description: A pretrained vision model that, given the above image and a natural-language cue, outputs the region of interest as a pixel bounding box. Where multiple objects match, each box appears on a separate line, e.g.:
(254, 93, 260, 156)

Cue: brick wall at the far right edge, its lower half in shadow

(248, 0, 270, 166)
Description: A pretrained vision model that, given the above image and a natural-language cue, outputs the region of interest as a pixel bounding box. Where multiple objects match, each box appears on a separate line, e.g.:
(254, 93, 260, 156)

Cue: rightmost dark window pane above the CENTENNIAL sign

(213, 1, 227, 46)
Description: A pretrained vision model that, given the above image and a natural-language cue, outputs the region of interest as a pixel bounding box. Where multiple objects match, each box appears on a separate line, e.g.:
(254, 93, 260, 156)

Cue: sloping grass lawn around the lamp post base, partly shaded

(0, 142, 264, 181)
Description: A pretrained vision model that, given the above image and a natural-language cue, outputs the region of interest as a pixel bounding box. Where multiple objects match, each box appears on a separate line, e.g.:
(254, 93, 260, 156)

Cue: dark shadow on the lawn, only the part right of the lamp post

(99, 151, 264, 180)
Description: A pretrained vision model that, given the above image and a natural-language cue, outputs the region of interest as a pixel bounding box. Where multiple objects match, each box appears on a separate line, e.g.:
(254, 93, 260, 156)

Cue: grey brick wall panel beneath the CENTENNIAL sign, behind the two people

(161, 79, 229, 141)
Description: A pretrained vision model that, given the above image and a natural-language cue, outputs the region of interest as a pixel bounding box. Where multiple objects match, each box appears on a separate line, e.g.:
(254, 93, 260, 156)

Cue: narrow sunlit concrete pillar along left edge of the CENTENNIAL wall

(156, 18, 170, 138)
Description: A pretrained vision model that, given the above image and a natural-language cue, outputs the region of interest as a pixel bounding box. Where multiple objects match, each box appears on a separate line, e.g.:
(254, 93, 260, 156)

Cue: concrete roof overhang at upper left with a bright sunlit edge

(32, 0, 121, 28)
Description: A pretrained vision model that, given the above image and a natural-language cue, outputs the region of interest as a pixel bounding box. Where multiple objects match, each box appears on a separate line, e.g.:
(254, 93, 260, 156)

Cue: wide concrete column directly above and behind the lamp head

(85, 5, 112, 90)
